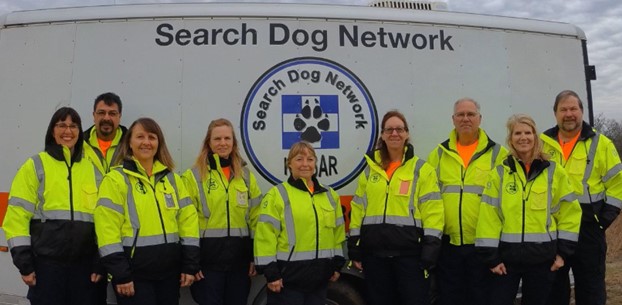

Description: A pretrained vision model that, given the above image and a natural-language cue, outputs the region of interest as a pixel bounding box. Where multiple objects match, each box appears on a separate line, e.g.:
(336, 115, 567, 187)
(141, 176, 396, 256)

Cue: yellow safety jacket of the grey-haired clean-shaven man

(427, 129, 508, 246)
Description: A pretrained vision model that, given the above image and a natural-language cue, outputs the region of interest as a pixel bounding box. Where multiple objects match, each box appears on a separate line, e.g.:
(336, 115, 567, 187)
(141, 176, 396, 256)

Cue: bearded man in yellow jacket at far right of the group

(540, 90, 622, 305)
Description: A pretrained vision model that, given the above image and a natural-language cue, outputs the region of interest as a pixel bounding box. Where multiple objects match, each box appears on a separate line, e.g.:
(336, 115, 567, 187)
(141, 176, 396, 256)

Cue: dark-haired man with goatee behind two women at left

(84, 92, 127, 176)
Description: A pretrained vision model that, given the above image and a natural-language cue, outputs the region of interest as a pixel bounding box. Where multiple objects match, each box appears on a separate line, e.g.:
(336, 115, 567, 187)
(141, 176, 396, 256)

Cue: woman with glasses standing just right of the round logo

(348, 110, 444, 305)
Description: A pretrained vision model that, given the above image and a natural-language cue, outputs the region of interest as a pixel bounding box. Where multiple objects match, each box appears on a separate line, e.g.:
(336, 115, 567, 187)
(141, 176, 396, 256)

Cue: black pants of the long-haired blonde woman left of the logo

(190, 270, 251, 305)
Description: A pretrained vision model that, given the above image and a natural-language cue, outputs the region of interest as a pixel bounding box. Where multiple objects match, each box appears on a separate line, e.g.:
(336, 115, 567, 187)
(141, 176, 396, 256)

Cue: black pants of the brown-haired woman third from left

(115, 276, 180, 305)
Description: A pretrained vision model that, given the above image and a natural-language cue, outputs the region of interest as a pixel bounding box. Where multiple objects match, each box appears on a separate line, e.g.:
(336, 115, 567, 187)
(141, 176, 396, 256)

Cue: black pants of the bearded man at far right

(548, 221, 607, 305)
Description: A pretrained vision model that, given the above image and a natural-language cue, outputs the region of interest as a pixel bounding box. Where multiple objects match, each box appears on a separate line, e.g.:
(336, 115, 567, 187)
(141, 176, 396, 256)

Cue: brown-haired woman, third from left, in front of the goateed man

(95, 118, 199, 305)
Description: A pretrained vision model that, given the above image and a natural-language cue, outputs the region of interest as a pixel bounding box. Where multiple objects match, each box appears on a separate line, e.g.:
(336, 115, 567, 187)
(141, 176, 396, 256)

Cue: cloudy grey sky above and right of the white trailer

(0, 0, 622, 120)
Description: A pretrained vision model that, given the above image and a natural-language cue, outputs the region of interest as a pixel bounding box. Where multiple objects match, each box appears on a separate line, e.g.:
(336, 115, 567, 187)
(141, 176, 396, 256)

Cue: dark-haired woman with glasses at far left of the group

(3, 107, 102, 305)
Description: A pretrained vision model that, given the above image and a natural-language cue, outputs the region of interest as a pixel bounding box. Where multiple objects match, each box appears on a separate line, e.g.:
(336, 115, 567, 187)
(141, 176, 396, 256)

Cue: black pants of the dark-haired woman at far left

(28, 259, 96, 305)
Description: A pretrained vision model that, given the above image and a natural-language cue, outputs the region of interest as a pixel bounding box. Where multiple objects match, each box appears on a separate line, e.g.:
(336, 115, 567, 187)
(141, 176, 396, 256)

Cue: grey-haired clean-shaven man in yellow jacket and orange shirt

(428, 98, 507, 305)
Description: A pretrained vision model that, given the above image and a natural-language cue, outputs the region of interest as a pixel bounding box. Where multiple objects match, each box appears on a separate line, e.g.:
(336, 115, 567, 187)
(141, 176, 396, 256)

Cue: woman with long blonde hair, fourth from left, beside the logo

(182, 119, 261, 305)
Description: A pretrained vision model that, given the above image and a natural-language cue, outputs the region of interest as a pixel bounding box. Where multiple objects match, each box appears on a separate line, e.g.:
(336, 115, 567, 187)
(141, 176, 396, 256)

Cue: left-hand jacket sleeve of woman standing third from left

(94, 171, 133, 284)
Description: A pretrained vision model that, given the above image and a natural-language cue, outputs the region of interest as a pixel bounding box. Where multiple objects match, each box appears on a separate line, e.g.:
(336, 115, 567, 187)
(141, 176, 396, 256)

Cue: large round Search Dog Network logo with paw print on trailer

(240, 57, 378, 189)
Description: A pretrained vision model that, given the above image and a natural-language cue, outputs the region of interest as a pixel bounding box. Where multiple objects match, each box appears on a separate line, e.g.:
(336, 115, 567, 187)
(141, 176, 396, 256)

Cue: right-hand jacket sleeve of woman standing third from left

(174, 174, 200, 275)
